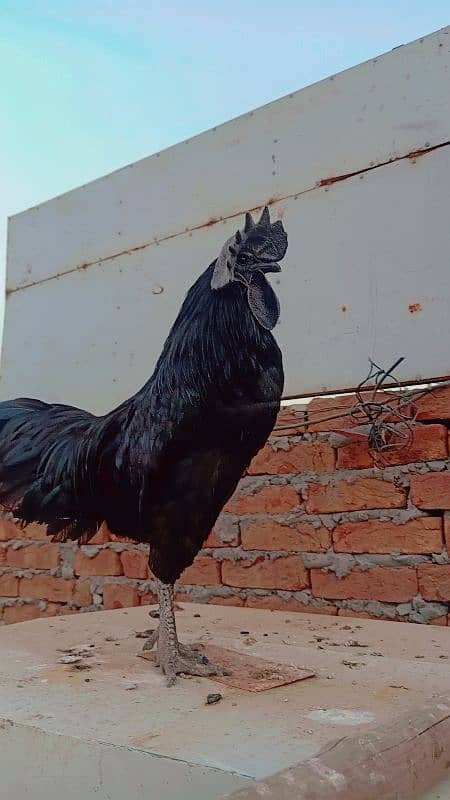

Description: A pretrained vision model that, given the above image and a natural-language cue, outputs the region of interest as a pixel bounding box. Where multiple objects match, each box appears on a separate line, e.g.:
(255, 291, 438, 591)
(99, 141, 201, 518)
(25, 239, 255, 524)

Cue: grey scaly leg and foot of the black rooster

(149, 581, 228, 686)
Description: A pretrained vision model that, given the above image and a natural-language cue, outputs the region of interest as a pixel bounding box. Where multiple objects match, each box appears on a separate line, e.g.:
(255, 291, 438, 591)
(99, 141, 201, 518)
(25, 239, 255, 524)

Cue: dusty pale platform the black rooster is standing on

(0, 604, 450, 800)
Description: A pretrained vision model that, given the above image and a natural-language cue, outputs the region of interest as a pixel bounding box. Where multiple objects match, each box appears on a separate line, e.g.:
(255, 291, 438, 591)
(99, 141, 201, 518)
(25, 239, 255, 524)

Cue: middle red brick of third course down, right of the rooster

(306, 478, 406, 514)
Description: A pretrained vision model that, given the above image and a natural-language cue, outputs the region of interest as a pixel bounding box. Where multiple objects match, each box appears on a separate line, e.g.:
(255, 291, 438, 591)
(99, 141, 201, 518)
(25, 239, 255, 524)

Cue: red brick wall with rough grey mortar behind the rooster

(0, 389, 450, 625)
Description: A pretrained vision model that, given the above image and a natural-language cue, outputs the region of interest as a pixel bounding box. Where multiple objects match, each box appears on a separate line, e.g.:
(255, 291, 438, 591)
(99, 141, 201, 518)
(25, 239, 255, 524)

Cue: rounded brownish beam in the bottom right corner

(230, 697, 450, 800)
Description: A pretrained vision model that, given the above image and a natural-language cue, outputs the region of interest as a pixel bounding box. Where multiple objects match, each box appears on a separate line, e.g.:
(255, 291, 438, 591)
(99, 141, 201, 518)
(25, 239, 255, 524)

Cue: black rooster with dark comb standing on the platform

(0, 208, 287, 684)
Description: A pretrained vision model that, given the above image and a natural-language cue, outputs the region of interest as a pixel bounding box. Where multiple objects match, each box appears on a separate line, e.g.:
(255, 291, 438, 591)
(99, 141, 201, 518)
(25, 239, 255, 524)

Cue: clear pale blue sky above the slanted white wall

(0, 0, 450, 314)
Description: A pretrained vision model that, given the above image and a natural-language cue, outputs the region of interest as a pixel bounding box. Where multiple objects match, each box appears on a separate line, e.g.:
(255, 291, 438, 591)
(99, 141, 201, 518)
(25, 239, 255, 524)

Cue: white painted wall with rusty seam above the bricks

(0, 28, 450, 412)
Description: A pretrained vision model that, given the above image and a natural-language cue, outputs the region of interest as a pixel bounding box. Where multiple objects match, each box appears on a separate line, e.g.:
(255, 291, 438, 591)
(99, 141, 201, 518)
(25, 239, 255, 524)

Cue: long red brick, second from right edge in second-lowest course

(311, 567, 418, 603)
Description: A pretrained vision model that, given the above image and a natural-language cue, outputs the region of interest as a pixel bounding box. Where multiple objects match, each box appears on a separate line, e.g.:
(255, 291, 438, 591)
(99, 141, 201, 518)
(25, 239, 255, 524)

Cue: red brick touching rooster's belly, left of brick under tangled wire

(248, 442, 335, 475)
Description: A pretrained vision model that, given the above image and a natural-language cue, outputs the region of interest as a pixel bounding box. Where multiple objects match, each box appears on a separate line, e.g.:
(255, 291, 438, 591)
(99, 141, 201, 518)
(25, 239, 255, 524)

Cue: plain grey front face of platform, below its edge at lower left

(0, 721, 252, 800)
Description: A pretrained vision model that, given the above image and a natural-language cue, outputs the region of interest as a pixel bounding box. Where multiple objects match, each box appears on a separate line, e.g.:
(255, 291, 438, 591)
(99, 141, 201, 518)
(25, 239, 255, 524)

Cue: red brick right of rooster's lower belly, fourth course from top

(241, 519, 331, 553)
